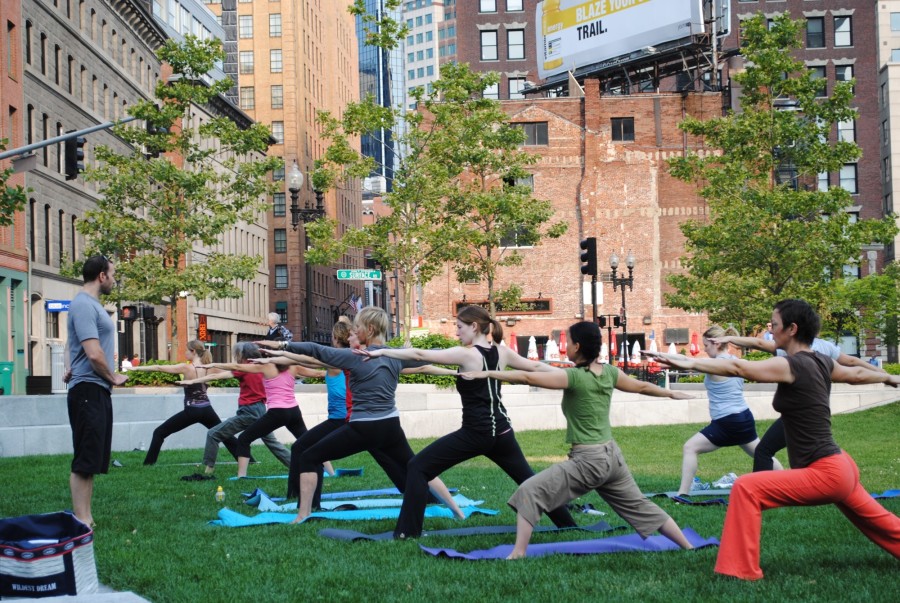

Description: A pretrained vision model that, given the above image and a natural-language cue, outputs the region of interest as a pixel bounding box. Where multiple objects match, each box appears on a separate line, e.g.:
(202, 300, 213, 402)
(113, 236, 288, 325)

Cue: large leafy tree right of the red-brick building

(666, 15, 897, 338)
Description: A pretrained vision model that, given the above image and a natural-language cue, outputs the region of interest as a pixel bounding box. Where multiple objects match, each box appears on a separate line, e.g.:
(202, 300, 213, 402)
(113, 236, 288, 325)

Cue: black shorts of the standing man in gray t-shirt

(68, 383, 112, 475)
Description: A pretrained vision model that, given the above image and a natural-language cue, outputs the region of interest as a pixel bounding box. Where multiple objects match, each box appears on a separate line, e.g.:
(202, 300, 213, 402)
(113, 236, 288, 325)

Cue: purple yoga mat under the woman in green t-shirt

(419, 528, 719, 561)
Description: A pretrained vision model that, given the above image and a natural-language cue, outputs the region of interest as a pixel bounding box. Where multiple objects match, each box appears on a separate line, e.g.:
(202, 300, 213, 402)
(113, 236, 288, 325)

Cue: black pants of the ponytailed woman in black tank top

(394, 428, 577, 537)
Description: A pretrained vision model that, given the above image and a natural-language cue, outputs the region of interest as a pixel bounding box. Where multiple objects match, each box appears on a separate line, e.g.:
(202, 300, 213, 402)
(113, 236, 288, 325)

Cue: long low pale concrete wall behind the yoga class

(0, 384, 900, 462)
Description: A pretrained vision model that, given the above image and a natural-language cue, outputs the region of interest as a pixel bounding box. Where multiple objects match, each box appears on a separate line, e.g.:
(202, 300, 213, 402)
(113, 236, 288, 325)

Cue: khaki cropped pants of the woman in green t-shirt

(509, 440, 669, 538)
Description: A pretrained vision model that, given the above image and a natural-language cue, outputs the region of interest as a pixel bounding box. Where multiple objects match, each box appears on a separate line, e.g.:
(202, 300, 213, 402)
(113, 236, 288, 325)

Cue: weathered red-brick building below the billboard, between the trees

(422, 80, 721, 351)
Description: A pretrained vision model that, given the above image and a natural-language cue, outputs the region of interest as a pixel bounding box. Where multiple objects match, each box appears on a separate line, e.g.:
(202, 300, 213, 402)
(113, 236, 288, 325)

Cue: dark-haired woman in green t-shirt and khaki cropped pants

(466, 322, 693, 559)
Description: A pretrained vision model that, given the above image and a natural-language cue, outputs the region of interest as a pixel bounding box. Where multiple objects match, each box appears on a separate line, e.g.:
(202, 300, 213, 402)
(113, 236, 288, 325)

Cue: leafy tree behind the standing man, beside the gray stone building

(78, 36, 283, 355)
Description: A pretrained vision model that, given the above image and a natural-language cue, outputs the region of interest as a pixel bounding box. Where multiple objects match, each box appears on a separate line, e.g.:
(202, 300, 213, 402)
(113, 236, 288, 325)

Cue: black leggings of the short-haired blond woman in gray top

(300, 417, 422, 492)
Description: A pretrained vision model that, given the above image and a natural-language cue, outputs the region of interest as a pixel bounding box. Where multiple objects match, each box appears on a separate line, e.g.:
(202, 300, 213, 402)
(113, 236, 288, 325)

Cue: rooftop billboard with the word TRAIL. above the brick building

(535, 0, 704, 79)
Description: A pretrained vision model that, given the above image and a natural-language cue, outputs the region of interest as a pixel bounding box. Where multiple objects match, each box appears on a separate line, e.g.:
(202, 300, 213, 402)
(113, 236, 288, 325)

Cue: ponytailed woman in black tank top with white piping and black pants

(360, 306, 576, 538)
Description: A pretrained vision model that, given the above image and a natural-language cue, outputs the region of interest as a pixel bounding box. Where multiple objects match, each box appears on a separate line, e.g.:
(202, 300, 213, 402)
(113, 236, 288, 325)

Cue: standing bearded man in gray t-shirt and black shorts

(63, 255, 128, 526)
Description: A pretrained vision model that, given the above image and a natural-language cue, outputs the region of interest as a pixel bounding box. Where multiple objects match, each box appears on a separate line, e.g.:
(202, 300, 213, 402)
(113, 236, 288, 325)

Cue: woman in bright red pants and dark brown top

(649, 299, 900, 580)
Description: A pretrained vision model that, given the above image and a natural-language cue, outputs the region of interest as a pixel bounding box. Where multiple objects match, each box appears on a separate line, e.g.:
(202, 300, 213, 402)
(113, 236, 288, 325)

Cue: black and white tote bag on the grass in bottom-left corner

(0, 512, 98, 597)
